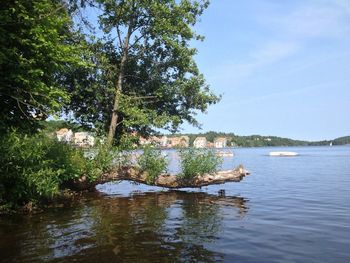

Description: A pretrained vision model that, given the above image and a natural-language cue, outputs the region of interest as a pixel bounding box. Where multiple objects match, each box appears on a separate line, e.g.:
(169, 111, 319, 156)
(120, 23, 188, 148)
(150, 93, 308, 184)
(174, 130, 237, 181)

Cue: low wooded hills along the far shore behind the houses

(169, 131, 350, 147)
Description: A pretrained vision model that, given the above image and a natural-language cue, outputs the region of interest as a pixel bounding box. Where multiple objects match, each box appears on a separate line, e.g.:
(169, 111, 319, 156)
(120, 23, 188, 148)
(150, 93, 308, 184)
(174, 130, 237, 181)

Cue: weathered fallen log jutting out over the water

(68, 166, 249, 190)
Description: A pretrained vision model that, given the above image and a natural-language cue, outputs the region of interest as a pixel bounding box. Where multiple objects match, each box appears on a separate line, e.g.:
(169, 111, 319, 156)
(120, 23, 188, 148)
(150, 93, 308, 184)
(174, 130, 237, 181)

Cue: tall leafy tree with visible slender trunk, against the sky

(65, 0, 219, 144)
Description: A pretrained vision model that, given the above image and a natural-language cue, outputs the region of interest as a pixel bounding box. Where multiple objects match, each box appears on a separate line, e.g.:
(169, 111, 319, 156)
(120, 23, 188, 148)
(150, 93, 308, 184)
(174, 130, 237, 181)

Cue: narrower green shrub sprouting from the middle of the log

(137, 146, 168, 184)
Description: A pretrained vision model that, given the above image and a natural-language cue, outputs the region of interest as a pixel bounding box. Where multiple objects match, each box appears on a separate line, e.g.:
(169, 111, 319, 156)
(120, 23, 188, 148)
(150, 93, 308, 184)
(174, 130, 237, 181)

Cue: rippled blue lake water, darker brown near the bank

(0, 146, 350, 262)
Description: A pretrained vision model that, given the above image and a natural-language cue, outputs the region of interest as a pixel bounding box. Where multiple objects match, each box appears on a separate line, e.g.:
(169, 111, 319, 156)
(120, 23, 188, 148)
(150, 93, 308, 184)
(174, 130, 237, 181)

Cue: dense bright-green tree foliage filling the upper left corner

(0, 0, 87, 132)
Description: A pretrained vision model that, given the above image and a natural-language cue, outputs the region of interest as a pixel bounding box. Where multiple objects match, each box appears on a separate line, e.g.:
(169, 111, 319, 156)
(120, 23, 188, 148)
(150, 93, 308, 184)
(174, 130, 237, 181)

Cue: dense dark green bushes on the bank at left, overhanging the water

(0, 132, 112, 210)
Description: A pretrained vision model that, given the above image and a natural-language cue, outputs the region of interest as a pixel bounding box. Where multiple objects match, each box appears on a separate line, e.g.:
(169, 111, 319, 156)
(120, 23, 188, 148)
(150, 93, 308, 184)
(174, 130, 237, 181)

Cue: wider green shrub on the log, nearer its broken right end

(179, 148, 223, 180)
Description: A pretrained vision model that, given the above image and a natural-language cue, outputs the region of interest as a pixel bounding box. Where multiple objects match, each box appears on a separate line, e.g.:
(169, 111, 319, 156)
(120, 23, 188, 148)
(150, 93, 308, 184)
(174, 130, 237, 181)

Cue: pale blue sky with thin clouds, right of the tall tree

(182, 0, 350, 140)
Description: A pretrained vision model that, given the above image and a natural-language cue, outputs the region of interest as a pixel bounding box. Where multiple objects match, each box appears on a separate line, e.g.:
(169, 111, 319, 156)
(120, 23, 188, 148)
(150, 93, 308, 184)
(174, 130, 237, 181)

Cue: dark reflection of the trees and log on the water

(0, 191, 248, 262)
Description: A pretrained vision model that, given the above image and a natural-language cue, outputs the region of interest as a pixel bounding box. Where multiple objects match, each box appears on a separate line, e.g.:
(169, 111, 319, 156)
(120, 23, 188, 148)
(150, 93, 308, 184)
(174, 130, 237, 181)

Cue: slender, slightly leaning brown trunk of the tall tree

(107, 24, 132, 146)
